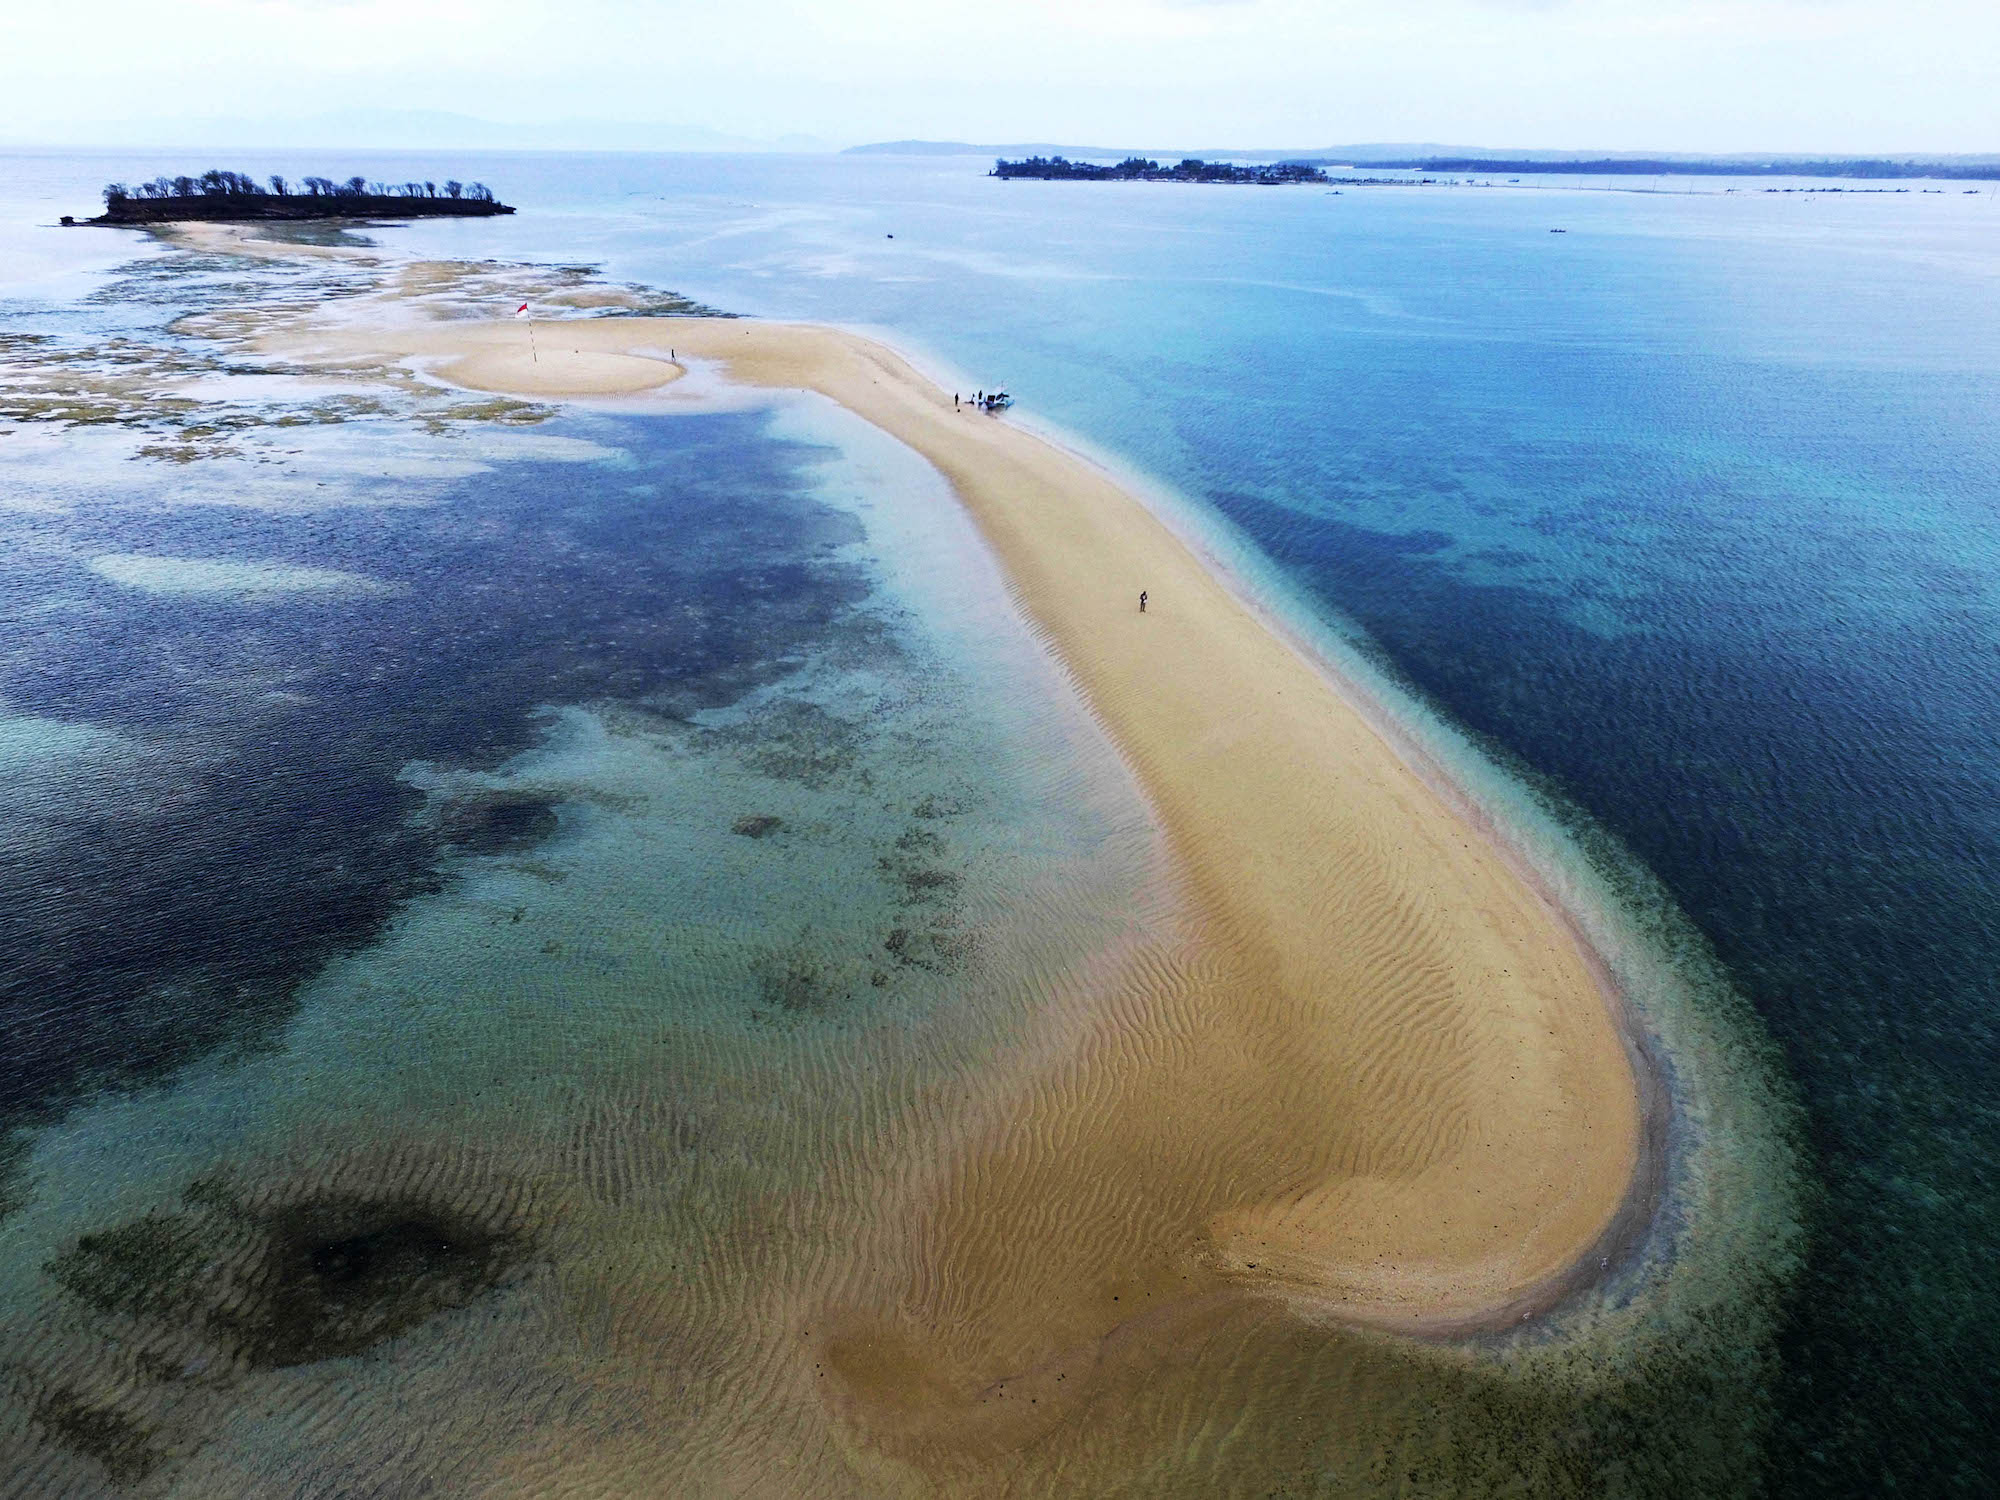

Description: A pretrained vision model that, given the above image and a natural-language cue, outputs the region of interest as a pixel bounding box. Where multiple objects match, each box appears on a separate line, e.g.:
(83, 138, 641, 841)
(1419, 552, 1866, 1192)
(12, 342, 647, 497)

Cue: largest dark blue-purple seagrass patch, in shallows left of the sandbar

(0, 414, 876, 1160)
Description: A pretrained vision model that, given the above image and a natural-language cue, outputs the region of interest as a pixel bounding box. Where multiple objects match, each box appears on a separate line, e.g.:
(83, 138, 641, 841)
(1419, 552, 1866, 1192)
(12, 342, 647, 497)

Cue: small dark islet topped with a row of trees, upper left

(78, 170, 514, 224)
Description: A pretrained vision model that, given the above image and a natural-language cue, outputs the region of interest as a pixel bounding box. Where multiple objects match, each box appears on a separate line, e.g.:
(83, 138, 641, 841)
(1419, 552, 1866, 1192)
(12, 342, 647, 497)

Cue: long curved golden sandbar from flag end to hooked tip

(266, 304, 1650, 1336)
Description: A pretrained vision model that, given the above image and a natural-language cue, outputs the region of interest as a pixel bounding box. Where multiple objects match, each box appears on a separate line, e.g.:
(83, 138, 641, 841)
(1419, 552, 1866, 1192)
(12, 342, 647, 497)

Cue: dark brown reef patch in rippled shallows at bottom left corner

(0, 1152, 540, 1494)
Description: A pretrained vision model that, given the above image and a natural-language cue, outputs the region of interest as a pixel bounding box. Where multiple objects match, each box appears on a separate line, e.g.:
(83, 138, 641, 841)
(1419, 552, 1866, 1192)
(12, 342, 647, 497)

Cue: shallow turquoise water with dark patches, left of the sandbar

(0, 238, 1158, 1496)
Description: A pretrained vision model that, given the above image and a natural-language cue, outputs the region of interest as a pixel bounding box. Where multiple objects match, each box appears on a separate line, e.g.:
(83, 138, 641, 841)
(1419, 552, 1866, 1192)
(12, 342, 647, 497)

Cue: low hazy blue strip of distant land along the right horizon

(846, 140, 2000, 178)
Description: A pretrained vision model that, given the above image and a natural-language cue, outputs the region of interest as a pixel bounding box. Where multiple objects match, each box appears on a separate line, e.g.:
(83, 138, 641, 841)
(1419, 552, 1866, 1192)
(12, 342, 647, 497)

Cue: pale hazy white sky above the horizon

(0, 0, 2000, 152)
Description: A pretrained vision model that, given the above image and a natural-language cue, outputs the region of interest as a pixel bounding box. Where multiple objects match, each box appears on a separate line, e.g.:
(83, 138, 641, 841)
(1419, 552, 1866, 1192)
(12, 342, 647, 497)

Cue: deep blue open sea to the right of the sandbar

(0, 156, 2000, 1496)
